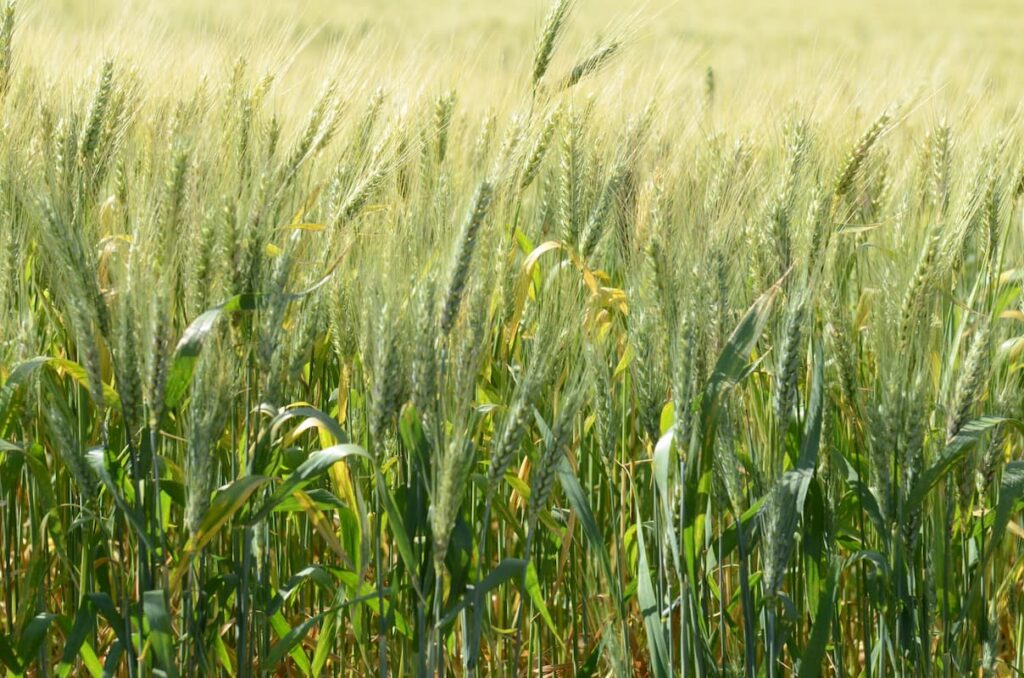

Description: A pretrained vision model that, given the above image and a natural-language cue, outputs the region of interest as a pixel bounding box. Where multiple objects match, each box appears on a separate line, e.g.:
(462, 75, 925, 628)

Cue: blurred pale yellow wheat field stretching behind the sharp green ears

(22, 0, 1024, 116)
